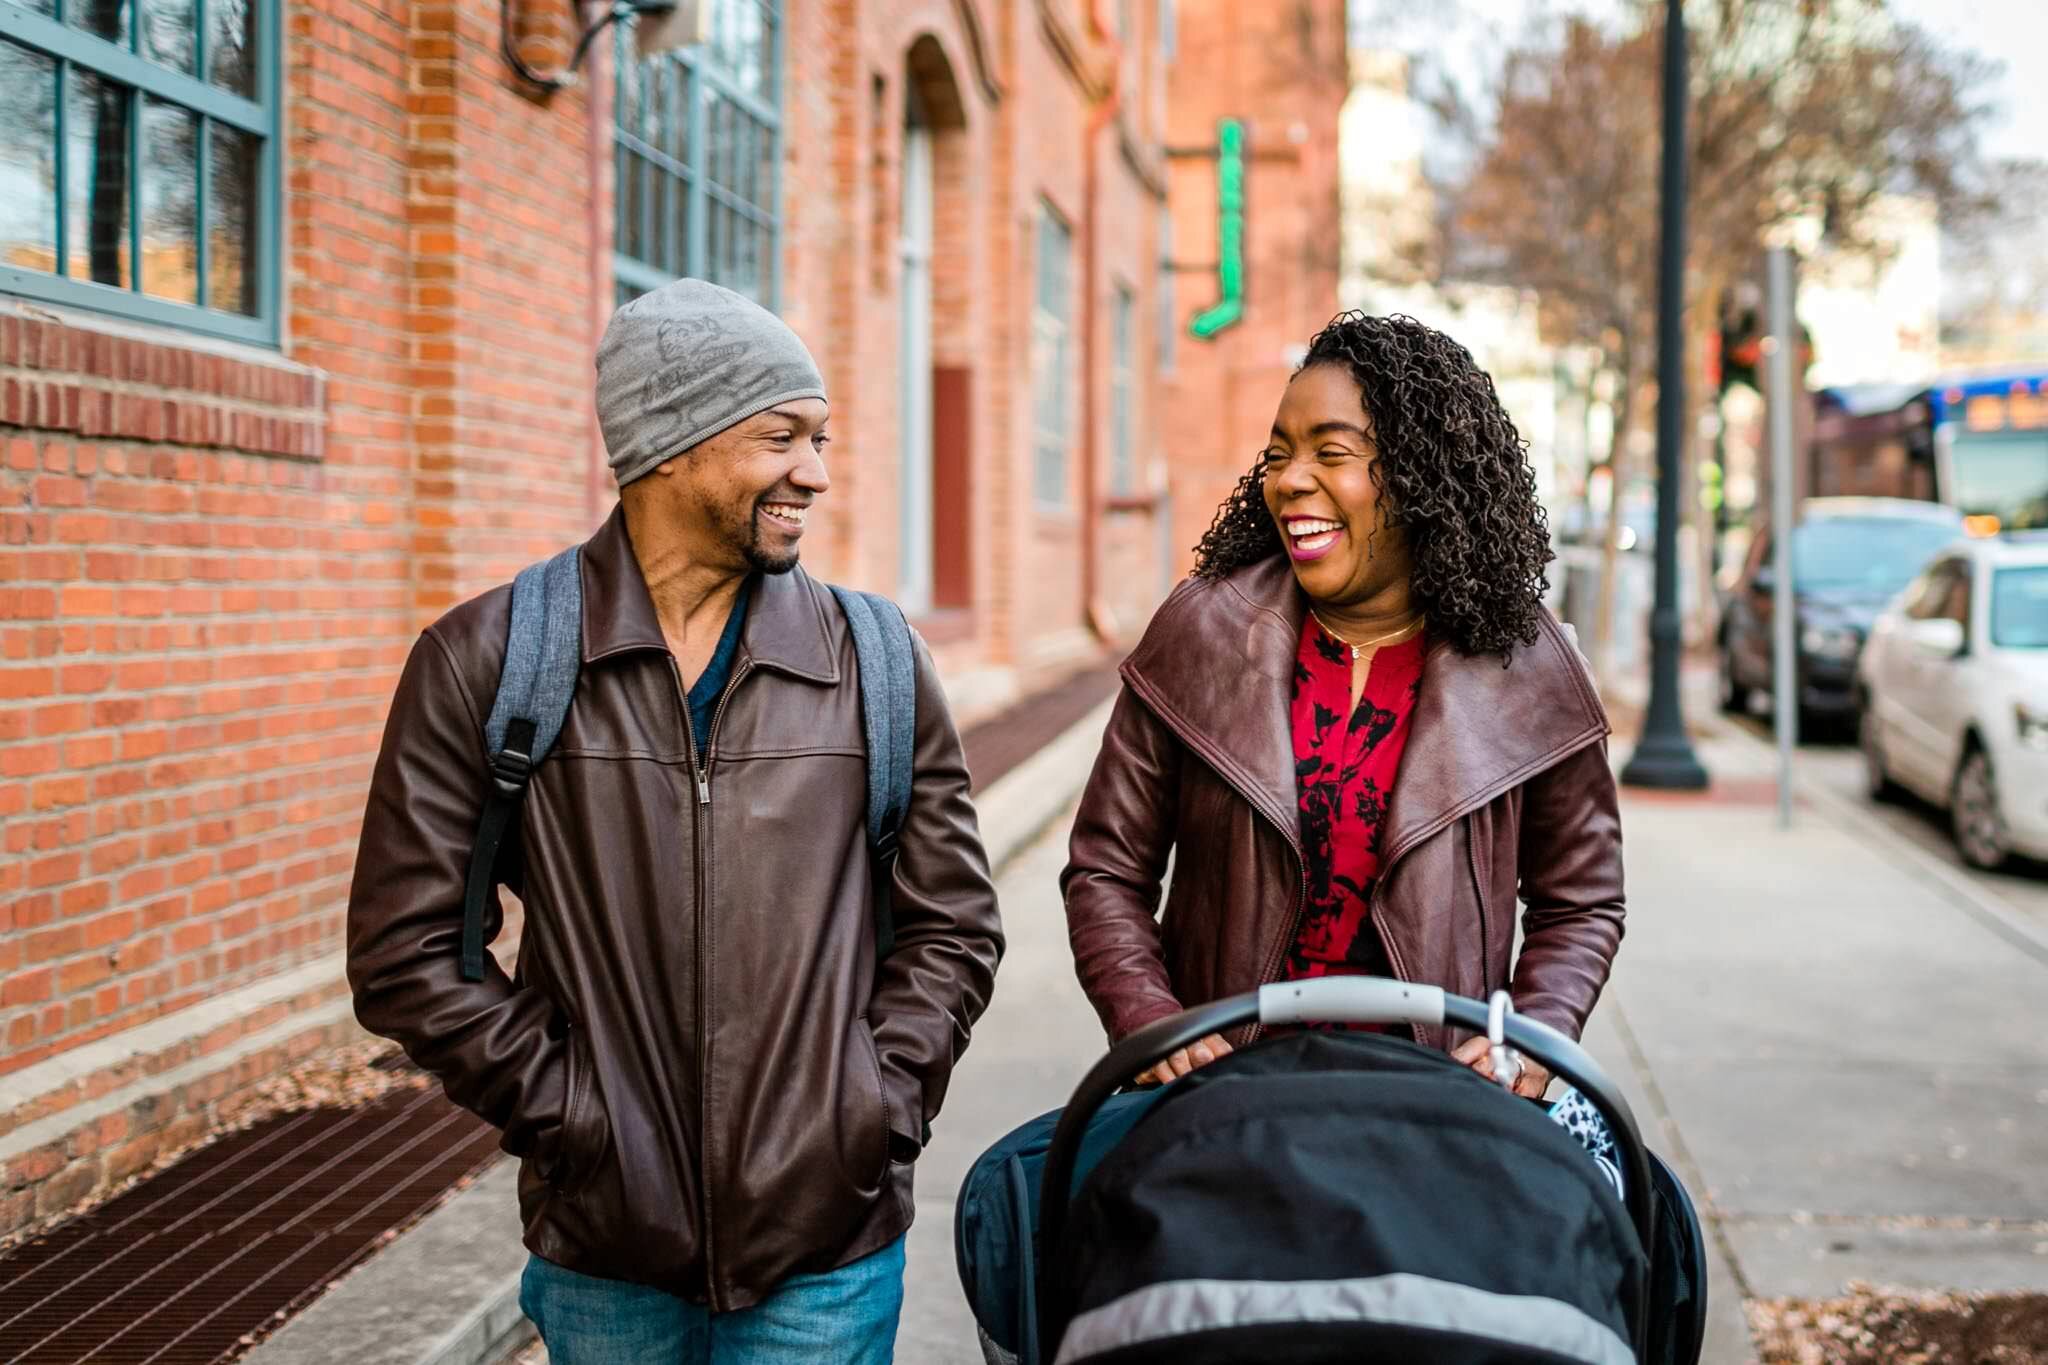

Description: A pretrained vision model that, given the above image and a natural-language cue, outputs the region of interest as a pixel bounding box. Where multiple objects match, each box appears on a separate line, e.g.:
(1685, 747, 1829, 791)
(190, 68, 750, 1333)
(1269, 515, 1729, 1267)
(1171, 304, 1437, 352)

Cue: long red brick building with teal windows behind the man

(0, 0, 1343, 1234)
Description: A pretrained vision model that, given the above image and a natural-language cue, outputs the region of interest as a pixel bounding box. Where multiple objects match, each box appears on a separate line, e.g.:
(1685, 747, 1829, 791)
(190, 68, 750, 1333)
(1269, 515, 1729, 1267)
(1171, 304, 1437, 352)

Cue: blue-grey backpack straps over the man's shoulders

(463, 546, 918, 980)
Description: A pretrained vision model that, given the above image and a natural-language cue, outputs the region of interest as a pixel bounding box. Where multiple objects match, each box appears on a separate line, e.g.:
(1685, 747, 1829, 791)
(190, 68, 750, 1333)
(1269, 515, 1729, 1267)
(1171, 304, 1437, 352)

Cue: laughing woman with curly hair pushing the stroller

(1061, 313, 1622, 1097)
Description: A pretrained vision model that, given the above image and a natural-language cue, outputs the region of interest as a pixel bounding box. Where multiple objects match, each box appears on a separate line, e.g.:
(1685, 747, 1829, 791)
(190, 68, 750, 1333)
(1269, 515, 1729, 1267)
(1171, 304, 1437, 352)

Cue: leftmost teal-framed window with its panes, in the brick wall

(0, 0, 279, 342)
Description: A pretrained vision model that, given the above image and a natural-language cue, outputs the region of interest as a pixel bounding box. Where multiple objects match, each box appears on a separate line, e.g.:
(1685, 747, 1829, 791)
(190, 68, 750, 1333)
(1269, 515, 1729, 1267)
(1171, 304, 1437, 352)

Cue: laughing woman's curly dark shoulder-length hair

(1194, 313, 1552, 661)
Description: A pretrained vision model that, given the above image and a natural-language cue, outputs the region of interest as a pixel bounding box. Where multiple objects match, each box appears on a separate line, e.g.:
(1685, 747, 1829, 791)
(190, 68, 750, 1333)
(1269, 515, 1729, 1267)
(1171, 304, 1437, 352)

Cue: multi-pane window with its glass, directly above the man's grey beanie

(610, 0, 782, 307)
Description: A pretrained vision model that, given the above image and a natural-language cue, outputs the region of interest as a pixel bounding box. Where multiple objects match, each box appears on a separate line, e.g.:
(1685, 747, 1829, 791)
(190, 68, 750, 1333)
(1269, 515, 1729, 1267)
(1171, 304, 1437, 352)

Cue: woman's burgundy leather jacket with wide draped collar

(1061, 559, 1622, 1048)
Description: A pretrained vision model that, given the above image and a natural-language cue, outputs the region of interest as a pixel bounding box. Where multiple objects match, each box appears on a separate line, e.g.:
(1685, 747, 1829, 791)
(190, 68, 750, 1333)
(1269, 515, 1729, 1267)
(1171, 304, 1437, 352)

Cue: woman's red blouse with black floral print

(1282, 616, 1423, 994)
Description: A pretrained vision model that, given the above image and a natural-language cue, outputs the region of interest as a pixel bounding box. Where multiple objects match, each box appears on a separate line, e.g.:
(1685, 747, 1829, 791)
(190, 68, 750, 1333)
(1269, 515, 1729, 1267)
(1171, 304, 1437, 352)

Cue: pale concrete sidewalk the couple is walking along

(268, 679, 2048, 1365)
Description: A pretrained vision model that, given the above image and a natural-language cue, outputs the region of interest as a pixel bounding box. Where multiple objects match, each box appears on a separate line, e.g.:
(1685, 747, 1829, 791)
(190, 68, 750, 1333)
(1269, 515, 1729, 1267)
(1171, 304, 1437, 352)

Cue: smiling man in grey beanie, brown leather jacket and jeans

(348, 280, 1004, 1365)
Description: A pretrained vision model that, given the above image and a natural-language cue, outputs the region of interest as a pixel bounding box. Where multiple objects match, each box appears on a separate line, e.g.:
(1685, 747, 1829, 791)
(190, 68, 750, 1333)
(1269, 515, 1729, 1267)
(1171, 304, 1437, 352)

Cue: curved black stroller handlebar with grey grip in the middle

(1038, 976, 1657, 1359)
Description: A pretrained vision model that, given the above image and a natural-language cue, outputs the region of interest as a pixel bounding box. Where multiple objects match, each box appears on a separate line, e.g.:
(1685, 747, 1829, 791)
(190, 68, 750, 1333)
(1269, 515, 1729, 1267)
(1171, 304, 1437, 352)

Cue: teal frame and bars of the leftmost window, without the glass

(0, 0, 285, 348)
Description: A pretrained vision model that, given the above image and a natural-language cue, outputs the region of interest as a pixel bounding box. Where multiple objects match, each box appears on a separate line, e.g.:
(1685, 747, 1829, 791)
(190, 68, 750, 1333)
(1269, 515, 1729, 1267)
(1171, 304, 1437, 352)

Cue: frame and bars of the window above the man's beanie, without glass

(610, 0, 788, 311)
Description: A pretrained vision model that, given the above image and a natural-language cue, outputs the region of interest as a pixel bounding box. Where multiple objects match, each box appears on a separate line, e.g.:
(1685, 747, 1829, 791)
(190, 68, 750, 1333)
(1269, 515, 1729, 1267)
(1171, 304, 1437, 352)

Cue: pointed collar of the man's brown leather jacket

(582, 508, 840, 684)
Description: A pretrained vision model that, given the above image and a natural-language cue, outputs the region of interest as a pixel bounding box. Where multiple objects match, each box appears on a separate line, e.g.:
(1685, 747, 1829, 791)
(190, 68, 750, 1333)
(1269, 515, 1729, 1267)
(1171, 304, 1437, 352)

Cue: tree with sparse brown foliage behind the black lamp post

(1434, 0, 1991, 683)
